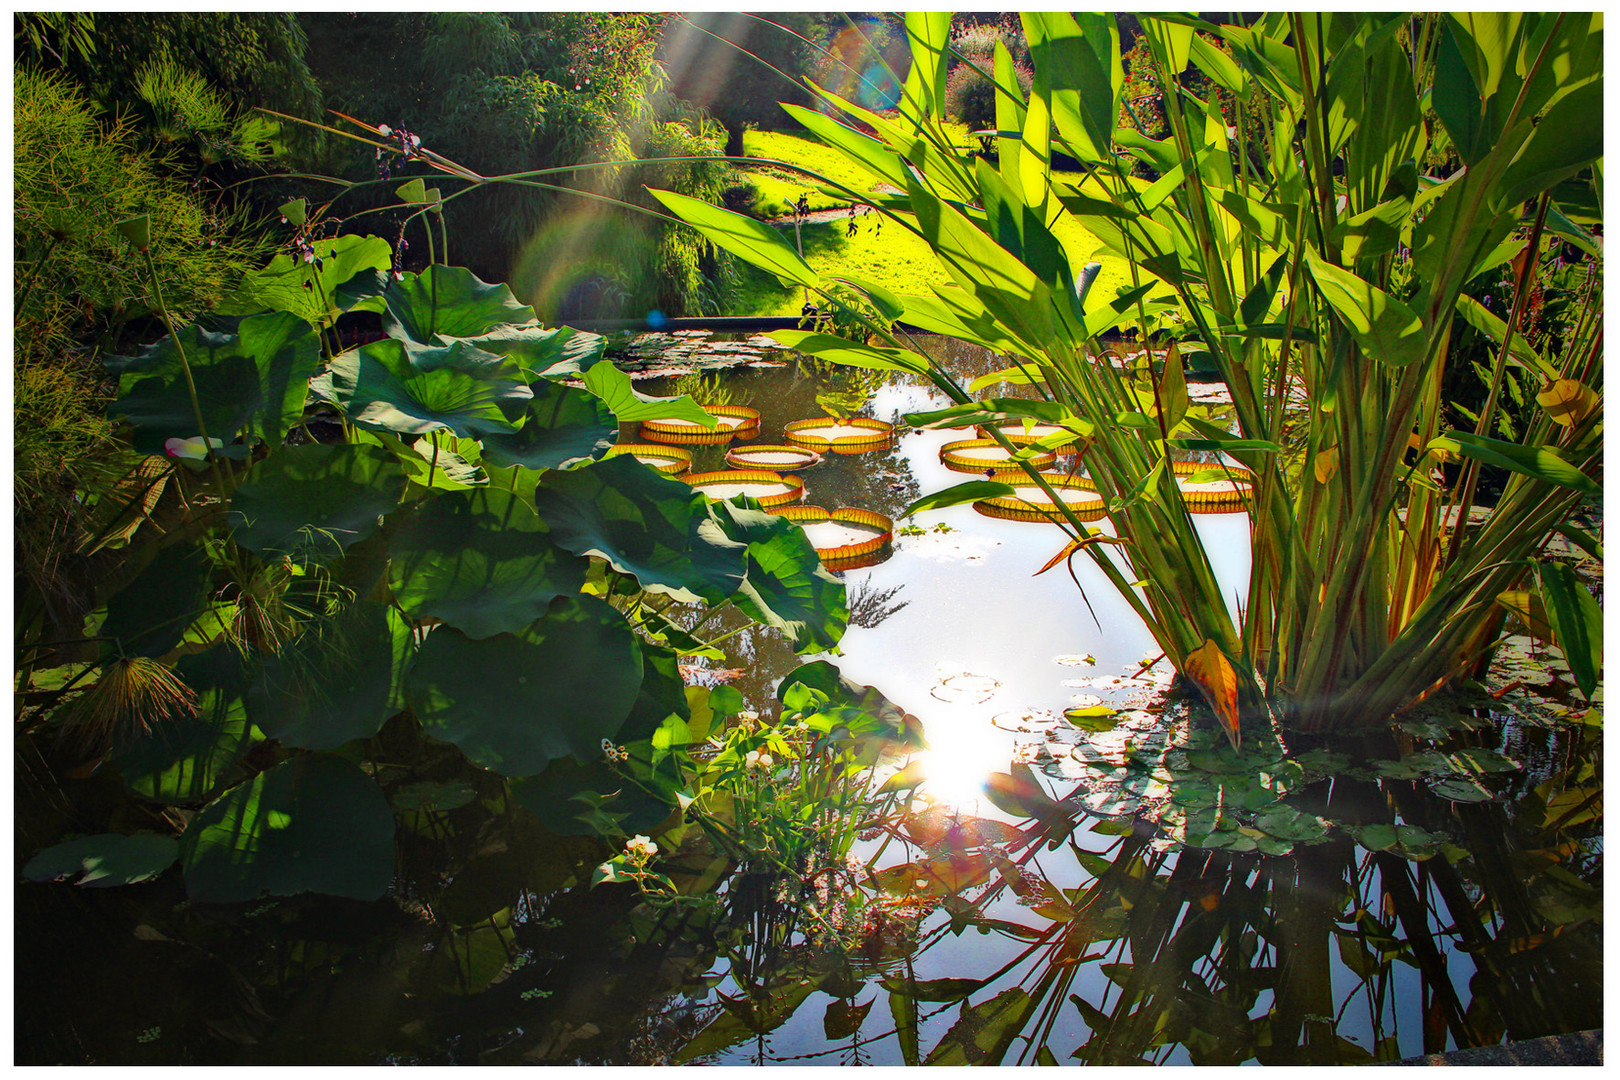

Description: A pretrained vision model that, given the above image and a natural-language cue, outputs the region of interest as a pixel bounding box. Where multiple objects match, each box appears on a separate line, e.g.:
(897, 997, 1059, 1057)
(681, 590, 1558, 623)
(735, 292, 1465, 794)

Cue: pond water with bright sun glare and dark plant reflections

(16, 331, 1602, 1065)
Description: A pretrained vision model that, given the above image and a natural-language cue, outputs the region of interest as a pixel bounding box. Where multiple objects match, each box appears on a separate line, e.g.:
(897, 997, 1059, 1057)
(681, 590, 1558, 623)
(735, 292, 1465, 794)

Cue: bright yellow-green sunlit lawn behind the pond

(726, 125, 1131, 316)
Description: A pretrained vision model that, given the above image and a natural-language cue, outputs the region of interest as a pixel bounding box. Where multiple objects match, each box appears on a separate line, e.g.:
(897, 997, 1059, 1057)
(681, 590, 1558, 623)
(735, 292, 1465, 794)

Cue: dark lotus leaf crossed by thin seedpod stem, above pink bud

(105, 311, 321, 453)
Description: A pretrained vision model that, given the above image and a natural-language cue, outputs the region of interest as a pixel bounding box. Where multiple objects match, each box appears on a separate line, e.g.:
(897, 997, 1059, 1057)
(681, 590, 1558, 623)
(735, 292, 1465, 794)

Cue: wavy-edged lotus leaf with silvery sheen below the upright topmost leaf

(313, 338, 533, 439)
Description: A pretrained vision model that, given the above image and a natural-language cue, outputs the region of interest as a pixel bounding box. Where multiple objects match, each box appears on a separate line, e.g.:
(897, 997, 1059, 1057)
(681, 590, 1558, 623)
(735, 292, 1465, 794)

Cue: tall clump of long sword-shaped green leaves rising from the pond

(663, 13, 1602, 735)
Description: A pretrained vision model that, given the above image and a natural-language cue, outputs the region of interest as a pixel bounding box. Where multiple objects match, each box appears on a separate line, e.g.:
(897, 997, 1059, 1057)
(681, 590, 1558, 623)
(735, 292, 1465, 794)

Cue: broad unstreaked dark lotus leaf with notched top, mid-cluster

(410, 596, 642, 776)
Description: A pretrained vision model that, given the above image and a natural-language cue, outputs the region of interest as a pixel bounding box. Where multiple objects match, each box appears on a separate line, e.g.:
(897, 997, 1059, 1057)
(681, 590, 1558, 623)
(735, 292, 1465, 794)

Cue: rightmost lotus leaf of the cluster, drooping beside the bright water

(710, 504, 849, 653)
